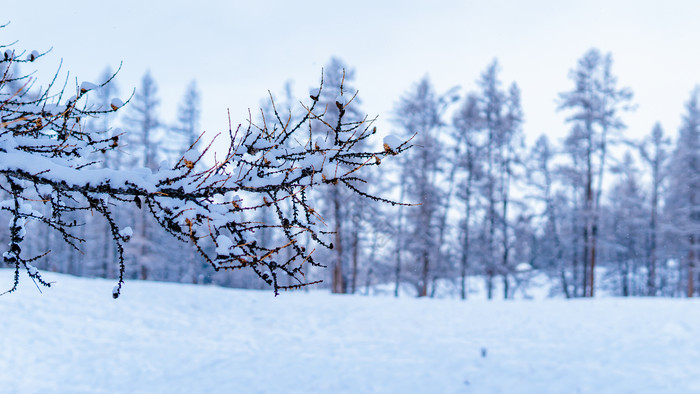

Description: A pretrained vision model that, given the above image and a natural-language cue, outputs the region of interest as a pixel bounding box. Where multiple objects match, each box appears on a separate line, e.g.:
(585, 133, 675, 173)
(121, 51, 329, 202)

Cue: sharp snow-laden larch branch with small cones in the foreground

(0, 38, 406, 298)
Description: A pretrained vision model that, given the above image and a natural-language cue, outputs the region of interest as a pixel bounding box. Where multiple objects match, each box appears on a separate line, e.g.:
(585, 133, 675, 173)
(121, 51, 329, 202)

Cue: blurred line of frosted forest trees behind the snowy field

(0, 49, 700, 299)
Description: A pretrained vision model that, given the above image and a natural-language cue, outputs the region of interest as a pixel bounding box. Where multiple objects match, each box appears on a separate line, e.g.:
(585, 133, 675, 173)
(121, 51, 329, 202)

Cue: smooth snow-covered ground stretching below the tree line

(0, 270, 700, 393)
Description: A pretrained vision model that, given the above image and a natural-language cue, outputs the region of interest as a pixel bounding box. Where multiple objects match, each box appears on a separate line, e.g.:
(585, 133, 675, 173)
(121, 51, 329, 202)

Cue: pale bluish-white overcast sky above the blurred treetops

(5, 0, 700, 148)
